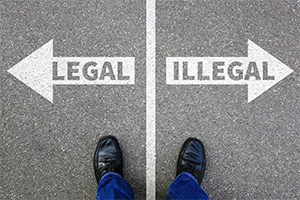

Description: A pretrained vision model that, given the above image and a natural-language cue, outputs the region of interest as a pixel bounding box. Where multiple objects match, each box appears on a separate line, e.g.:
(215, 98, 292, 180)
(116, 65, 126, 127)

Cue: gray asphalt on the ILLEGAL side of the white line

(156, 0, 300, 200)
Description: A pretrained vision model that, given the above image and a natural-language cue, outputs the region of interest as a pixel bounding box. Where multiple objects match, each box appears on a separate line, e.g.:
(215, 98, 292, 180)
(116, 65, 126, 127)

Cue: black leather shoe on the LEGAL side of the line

(94, 136, 123, 183)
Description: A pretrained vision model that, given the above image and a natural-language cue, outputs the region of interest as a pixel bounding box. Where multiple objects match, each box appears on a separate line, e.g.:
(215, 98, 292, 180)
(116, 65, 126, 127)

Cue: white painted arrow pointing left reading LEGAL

(8, 40, 135, 103)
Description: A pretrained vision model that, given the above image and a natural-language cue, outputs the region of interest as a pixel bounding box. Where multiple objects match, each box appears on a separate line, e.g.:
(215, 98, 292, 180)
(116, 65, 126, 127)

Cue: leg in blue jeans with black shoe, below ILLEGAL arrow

(167, 138, 208, 200)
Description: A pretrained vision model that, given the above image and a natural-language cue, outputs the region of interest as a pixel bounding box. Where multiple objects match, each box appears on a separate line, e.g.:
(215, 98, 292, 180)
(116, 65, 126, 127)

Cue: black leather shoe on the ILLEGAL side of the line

(176, 138, 206, 185)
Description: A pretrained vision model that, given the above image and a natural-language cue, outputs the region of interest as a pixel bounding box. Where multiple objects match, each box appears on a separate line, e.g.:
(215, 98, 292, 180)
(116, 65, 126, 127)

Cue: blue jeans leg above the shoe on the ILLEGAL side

(167, 172, 208, 200)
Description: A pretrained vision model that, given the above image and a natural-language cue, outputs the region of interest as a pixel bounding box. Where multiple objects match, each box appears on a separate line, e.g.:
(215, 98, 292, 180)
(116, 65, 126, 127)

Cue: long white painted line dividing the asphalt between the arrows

(146, 0, 156, 200)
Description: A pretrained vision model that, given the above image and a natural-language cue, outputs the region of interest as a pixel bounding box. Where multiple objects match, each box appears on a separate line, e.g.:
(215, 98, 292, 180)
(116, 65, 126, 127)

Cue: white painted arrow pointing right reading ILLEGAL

(166, 40, 293, 103)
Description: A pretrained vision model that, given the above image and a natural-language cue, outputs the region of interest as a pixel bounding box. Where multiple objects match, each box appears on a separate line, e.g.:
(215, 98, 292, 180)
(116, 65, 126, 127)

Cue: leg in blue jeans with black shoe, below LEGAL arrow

(94, 136, 134, 200)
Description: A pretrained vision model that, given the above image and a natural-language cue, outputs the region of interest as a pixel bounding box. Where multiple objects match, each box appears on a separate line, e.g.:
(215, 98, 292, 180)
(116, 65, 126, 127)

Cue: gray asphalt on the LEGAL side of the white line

(0, 0, 146, 200)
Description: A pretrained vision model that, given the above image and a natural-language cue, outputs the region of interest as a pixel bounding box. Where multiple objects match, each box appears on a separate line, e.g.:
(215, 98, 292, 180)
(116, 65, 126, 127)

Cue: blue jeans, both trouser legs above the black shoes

(96, 173, 208, 200)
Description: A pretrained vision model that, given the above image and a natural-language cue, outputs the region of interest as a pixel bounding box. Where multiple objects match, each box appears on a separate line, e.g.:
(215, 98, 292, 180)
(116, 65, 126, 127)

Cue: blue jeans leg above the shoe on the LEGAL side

(96, 172, 134, 200)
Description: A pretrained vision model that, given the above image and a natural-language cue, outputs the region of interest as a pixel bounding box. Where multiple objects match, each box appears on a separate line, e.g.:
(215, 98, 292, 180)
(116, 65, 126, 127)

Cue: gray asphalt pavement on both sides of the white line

(0, 0, 300, 200)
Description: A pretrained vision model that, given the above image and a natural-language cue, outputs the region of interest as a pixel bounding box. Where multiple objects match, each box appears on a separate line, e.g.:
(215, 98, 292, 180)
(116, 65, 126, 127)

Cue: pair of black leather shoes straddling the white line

(94, 136, 206, 185)
